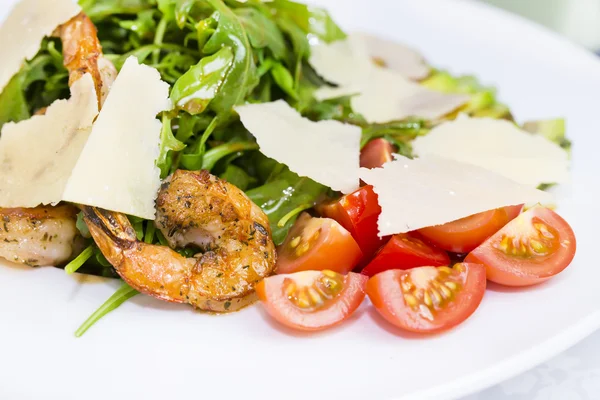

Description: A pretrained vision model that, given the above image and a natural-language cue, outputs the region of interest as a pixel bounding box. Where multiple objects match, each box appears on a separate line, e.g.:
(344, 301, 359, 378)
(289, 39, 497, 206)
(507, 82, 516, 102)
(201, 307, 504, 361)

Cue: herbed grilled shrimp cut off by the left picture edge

(0, 204, 83, 267)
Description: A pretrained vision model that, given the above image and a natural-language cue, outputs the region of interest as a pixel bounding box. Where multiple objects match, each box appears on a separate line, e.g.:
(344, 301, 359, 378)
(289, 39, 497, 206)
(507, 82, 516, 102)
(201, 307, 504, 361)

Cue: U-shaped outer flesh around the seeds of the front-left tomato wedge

(256, 271, 369, 331)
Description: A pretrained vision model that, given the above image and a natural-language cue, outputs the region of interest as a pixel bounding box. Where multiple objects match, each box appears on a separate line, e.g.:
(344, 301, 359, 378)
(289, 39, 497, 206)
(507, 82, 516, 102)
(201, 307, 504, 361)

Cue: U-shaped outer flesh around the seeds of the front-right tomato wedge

(367, 263, 486, 333)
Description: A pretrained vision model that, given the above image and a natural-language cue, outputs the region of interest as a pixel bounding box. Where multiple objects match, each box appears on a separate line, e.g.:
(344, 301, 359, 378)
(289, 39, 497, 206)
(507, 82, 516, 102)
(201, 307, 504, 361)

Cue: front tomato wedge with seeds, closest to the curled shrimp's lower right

(256, 270, 369, 331)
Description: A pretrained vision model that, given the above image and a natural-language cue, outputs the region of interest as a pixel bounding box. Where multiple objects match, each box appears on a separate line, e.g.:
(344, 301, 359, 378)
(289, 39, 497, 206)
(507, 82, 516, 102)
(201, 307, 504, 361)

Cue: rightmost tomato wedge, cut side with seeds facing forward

(466, 207, 577, 286)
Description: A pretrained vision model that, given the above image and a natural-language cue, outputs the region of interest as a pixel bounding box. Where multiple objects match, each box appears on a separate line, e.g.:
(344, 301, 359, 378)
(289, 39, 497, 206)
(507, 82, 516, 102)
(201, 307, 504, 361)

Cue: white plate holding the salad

(0, 0, 600, 400)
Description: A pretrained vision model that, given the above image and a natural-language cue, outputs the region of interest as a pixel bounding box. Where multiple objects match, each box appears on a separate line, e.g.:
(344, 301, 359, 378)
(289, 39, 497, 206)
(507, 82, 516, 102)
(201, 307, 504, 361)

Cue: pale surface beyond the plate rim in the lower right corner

(461, 332, 600, 400)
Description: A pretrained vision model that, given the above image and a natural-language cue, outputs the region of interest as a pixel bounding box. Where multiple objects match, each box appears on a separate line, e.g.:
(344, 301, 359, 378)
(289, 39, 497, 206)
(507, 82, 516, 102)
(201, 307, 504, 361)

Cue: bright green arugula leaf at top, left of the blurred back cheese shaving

(234, 7, 288, 60)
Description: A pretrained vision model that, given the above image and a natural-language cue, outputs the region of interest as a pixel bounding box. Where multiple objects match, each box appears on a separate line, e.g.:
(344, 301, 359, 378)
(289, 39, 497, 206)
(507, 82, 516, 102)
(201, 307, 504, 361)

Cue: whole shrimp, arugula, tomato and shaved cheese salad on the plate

(0, 0, 576, 336)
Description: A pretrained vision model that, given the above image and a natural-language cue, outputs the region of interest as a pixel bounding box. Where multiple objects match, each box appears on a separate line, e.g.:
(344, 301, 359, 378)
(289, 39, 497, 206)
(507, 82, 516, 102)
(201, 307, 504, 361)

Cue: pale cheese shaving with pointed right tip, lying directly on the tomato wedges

(360, 156, 552, 236)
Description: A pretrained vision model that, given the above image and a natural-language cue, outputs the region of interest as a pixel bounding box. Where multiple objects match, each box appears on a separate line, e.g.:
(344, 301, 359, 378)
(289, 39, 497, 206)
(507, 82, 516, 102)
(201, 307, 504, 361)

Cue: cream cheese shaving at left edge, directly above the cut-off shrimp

(0, 74, 98, 207)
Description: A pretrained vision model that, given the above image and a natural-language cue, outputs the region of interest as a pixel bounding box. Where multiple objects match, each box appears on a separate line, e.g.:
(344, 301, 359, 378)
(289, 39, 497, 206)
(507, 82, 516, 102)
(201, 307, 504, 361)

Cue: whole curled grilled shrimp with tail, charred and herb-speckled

(83, 170, 276, 312)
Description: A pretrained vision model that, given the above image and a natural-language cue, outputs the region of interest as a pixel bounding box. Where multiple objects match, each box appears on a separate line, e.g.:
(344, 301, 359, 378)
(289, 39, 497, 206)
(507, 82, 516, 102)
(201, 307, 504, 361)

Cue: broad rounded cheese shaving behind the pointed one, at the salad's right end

(412, 116, 569, 186)
